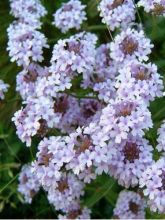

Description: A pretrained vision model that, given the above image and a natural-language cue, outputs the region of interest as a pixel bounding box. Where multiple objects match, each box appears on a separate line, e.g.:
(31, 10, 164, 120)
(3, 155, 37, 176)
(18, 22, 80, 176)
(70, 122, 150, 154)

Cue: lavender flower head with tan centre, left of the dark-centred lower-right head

(66, 128, 116, 177)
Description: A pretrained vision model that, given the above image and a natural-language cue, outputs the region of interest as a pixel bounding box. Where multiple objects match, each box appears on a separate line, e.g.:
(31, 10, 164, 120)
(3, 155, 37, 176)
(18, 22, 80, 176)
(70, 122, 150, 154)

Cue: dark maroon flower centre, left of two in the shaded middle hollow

(54, 97, 69, 114)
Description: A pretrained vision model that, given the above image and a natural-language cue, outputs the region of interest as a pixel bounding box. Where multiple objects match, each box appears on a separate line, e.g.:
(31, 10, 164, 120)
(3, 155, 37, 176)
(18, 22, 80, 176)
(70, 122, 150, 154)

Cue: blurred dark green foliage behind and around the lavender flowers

(0, 0, 165, 219)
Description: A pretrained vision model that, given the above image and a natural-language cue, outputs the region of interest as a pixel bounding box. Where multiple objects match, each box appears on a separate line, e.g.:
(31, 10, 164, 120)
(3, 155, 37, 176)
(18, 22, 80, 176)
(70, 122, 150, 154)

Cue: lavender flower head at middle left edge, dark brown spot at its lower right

(12, 96, 59, 146)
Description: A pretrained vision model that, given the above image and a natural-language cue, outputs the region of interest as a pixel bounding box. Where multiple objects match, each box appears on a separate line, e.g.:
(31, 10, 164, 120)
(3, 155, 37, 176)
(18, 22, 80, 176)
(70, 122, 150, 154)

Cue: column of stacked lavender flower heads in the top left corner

(7, 0, 48, 68)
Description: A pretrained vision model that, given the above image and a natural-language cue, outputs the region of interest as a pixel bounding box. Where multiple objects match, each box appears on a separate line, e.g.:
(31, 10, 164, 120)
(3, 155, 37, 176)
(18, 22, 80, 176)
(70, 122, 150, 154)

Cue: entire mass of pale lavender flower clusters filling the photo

(7, 0, 165, 219)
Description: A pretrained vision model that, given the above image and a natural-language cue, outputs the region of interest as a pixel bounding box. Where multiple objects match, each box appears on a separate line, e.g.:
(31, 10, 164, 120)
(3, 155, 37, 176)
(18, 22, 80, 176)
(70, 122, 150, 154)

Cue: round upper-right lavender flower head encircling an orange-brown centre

(110, 28, 153, 63)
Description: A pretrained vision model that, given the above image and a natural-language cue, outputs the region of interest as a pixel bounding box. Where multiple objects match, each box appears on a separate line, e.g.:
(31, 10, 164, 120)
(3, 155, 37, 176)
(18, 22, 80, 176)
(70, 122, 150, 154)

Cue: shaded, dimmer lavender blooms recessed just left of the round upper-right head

(82, 44, 117, 102)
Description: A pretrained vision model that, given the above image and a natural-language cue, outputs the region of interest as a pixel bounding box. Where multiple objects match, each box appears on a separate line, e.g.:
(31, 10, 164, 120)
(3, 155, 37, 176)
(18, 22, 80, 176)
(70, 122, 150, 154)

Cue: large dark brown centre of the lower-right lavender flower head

(123, 142, 140, 163)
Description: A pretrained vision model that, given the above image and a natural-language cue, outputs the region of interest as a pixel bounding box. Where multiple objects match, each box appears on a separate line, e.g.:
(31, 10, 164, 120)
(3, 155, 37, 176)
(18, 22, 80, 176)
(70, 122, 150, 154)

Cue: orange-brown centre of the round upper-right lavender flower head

(120, 36, 138, 55)
